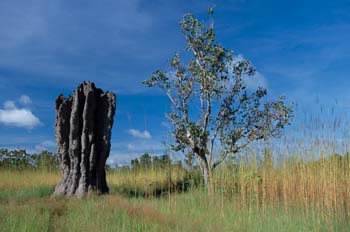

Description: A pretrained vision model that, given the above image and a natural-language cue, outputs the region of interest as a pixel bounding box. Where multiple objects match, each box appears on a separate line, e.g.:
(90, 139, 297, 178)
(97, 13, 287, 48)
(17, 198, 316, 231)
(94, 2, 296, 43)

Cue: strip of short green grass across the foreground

(0, 186, 350, 232)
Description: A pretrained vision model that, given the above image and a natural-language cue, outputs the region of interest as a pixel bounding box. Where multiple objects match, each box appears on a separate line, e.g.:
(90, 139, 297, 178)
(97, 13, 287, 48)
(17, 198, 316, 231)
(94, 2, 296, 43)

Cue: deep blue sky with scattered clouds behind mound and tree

(0, 0, 350, 164)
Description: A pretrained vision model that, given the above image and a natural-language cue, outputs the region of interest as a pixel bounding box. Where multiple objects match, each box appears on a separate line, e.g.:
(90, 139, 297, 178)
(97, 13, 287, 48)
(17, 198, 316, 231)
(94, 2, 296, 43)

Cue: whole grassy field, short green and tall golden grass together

(0, 156, 350, 232)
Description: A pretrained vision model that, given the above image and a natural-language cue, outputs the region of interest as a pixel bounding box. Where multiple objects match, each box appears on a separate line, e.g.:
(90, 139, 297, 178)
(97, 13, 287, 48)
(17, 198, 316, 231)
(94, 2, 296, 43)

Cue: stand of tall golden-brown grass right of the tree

(214, 155, 350, 226)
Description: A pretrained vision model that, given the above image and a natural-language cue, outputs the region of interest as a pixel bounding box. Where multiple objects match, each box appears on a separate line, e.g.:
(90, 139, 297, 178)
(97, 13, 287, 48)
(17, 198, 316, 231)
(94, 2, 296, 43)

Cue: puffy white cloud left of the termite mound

(0, 101, 40, 129)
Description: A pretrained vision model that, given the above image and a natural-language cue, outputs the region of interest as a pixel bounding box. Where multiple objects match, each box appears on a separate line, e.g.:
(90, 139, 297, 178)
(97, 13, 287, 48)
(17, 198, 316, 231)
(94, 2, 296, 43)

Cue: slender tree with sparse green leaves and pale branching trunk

(143, 9, 292, 188)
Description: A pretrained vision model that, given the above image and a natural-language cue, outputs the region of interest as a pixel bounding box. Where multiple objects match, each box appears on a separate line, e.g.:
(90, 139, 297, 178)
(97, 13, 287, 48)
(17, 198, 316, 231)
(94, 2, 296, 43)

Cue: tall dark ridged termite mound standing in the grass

(54, 82, 116, 197)
